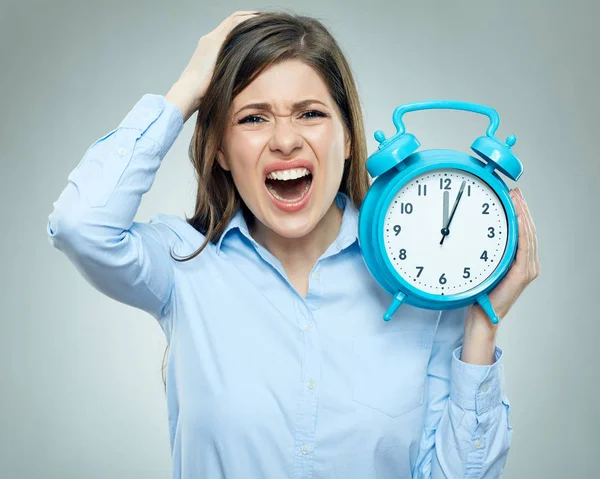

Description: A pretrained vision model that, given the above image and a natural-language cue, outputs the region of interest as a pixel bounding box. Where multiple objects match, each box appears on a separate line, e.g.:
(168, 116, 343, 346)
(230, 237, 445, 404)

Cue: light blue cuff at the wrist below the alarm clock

(450, 346, 504, 415)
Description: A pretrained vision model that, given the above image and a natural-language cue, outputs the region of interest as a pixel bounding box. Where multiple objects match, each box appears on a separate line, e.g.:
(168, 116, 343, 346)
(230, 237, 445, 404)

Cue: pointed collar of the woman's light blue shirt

(216, 191, 358, 254)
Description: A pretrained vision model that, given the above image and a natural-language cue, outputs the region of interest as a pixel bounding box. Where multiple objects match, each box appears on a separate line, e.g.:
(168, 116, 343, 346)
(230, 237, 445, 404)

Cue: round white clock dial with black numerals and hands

(383, 168, 508, 295)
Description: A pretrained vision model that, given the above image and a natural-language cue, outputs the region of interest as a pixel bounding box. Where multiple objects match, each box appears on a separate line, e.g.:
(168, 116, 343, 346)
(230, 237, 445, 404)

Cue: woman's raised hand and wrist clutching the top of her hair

(165, 10, 259, 122)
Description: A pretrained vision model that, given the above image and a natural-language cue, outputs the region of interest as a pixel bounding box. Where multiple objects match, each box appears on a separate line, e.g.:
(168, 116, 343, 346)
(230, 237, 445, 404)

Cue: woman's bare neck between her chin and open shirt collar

(249, 201, 343, 271)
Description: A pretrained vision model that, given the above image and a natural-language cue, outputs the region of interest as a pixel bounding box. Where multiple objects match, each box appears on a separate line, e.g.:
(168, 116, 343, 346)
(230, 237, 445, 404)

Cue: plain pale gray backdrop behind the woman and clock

(0, 0, 600, 479)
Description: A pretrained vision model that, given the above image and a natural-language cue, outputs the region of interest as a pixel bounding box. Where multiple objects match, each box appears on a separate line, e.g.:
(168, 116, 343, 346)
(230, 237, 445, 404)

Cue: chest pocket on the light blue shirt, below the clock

(352, 330, 433, 417)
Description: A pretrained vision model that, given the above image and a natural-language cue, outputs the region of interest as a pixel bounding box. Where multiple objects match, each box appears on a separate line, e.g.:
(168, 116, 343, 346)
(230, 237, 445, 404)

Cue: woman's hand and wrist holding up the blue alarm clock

(465, 188, 540, 340)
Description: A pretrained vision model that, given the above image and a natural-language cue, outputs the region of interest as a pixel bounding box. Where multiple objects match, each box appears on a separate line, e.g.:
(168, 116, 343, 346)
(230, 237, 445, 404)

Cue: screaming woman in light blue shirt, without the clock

(48, 8, 539, 479)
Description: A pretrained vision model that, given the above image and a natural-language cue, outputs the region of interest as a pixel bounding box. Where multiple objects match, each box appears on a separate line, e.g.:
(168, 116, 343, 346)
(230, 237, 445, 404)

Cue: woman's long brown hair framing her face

(163, 11, 369, 390)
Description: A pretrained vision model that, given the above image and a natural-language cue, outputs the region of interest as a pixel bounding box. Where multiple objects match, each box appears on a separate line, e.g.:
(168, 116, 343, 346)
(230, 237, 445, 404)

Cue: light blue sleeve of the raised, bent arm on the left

(46, 94, 184, 326)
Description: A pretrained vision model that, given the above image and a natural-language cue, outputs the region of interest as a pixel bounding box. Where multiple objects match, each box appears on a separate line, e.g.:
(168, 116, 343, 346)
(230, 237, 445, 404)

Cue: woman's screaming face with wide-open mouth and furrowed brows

(218, 60, 350, 242)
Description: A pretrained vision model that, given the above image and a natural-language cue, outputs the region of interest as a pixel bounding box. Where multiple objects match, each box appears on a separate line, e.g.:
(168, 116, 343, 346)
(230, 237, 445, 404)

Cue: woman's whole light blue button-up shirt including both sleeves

(47, 94, 512, 479)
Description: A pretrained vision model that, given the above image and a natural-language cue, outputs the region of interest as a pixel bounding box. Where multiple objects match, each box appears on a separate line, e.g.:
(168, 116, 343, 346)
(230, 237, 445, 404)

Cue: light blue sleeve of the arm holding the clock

(413, 307, 512, 479)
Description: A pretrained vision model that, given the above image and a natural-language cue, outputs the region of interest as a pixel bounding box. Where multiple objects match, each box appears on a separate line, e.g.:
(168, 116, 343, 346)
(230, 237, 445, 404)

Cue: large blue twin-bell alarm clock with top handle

(358, 100, 523, 323)
